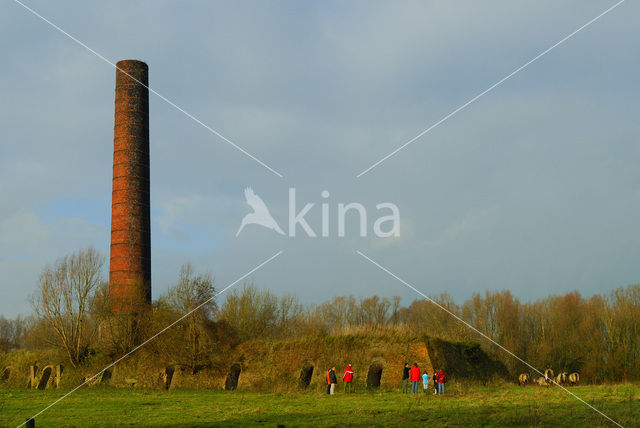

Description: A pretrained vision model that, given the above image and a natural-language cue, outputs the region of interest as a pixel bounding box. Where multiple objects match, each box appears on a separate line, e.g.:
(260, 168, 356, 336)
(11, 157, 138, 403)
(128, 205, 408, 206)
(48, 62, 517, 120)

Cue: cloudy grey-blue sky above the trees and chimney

(0, 0, 640, 317)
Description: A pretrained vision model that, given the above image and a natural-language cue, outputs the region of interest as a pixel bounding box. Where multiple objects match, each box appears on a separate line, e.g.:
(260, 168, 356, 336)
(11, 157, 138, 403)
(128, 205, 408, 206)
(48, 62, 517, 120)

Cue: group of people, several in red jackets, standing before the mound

(327, 363, 447, 395)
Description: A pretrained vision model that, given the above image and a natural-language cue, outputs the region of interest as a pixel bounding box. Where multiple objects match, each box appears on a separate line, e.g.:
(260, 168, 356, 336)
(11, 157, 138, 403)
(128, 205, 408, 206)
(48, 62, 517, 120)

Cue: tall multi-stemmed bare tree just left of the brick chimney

(31, 247, 104, 367)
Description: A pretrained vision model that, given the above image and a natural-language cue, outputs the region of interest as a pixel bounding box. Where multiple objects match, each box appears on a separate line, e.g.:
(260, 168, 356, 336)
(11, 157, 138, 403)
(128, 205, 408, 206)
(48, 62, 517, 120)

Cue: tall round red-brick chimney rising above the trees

(109, 60, 151, 312)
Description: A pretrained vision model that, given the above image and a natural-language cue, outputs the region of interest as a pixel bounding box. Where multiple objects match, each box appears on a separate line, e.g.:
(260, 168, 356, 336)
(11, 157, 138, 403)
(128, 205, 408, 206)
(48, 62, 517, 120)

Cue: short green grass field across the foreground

(0, 385, 640, 427)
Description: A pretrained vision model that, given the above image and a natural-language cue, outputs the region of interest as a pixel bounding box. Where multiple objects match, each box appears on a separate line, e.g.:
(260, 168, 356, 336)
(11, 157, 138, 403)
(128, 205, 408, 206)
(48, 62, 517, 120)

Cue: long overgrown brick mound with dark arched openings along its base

(0, 333, 508, 391)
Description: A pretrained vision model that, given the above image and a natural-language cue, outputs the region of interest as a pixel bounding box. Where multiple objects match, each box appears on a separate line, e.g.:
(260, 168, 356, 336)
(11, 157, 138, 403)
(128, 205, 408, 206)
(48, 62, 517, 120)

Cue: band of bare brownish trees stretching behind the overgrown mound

(0, 248, 640, 382)
